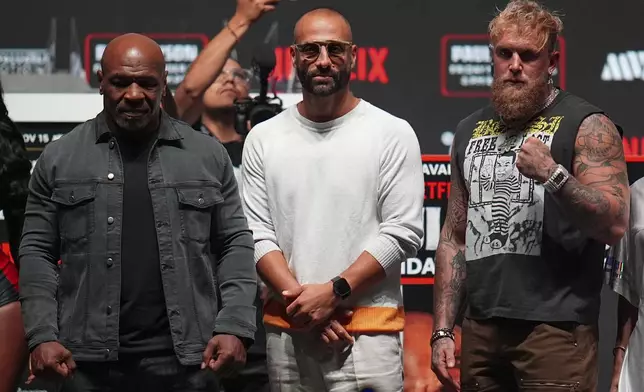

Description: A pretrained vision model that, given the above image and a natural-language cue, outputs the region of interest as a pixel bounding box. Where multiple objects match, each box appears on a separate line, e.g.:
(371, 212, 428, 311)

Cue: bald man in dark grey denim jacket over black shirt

(20, 34, 257, 392)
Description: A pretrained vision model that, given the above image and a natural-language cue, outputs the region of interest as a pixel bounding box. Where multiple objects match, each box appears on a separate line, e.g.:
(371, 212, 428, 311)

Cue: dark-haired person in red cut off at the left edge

(0, 77, 31, 392)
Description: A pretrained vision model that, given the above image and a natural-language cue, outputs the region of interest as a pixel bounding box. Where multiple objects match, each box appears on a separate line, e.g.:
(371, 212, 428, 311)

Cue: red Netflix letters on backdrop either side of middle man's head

(272, 46, 389, 93)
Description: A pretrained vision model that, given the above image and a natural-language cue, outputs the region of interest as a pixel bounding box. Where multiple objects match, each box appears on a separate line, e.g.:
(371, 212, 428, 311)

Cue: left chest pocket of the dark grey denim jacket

(51, 182, 97, 241)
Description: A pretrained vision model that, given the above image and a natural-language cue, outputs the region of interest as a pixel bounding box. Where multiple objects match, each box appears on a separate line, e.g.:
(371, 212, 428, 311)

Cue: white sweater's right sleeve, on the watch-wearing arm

(365, 120, 424, 274)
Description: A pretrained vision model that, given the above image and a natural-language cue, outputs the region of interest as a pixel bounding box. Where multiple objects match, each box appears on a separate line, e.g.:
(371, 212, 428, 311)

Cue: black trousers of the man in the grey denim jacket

(61, 355, 219, 392)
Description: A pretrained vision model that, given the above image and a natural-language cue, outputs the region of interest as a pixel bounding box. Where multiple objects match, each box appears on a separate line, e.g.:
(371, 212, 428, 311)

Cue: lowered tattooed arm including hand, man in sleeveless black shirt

(432, 148, 469, 386)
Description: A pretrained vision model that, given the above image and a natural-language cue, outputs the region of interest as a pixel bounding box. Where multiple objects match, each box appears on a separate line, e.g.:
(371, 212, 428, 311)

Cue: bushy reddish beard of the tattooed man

(491, 77, 550, 125)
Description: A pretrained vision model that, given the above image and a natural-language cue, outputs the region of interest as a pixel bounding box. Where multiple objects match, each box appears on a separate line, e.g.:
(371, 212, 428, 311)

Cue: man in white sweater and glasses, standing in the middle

(242, 9, 423, 392)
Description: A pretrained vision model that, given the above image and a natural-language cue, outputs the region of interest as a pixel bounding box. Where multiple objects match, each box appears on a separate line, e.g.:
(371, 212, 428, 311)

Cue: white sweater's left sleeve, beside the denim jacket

(241, 133, 280, 263)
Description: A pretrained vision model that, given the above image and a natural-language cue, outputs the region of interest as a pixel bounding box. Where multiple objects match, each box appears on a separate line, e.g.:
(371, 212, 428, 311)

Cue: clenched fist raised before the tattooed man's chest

(516, 137, 557, 184)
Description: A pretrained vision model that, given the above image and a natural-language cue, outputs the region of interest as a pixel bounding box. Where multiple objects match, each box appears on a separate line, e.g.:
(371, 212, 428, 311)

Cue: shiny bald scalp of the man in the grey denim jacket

(101, 33, 165, 73)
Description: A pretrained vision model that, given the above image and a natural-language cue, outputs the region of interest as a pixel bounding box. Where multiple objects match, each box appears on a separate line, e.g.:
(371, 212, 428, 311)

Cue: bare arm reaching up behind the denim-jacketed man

(174, 0, 279, 124)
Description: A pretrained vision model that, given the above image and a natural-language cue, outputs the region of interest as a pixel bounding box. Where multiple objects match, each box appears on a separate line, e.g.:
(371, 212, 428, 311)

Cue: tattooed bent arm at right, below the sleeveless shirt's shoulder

(556, 114, 630, 243)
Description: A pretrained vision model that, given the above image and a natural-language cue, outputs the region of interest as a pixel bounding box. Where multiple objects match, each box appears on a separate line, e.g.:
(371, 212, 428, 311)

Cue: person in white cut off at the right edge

(605, 178, 644, 392)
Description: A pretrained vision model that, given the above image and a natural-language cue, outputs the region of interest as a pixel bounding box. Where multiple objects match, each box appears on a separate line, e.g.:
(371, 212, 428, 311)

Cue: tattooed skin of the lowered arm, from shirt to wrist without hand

(434, 158, 468, 329)
